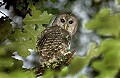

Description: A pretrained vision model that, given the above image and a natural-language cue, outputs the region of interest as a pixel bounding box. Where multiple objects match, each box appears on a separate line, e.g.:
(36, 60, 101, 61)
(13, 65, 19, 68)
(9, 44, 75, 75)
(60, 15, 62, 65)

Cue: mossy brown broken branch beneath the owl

(35, 50, 76, 77)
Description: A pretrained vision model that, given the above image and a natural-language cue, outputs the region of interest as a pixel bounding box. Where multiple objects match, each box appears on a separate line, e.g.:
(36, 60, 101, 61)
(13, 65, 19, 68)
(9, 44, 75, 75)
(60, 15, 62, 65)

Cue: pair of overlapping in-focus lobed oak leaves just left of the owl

(10, 11, 52, 56)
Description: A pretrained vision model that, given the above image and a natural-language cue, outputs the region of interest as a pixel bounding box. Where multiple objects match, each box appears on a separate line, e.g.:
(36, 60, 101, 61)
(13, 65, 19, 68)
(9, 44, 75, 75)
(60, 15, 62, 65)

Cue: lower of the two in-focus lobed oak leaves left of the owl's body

(11, 26, 40, 56)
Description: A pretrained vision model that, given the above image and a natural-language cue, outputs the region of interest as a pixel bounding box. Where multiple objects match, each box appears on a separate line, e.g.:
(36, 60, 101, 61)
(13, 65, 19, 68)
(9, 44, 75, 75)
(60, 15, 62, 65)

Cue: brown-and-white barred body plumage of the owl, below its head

(37, 26, 71, 62)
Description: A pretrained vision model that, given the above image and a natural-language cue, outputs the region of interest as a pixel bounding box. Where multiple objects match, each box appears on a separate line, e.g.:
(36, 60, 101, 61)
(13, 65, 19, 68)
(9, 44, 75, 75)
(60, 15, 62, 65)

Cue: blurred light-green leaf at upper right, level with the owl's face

(86, 9, 120, 38)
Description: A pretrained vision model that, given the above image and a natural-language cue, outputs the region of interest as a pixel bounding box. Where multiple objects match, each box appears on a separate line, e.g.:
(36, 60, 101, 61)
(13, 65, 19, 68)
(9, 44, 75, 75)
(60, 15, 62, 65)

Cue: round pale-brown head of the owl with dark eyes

(52, 13, 78, 35)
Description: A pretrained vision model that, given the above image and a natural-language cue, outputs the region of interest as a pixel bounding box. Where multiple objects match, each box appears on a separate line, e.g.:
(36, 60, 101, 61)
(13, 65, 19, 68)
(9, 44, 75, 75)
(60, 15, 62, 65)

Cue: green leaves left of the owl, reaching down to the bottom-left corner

(0, 6, 53, 78)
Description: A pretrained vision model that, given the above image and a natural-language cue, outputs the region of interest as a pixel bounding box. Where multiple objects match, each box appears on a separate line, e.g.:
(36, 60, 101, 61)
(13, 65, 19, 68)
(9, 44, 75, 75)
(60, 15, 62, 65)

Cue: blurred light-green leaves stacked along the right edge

(86, 9, 120, 78)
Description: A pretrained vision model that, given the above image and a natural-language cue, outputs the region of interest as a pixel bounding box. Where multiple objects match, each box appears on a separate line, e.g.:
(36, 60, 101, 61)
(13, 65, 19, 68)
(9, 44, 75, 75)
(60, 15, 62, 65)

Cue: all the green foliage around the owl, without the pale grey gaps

(0, 0, 120, 78)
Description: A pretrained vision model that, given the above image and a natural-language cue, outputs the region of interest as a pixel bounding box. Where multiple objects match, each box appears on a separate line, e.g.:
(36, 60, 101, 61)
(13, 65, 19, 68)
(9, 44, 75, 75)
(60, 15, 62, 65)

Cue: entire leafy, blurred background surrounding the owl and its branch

(0, 0, 120, 78)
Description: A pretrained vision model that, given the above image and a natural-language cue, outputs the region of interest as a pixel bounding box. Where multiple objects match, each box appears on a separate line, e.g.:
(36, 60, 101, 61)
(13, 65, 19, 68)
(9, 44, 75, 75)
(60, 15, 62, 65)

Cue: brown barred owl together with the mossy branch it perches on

(36, 13, 78, 76)
